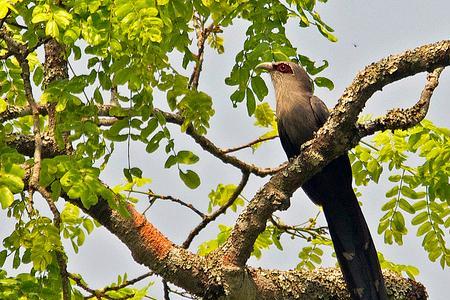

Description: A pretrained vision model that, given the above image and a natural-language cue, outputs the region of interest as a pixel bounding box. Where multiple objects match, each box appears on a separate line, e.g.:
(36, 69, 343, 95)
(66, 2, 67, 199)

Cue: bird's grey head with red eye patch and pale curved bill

(256, 61, 313, 93)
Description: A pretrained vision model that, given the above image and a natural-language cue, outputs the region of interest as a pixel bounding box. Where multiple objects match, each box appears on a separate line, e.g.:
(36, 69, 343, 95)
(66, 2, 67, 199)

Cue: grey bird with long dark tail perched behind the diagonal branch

(256, 61, 389, 300)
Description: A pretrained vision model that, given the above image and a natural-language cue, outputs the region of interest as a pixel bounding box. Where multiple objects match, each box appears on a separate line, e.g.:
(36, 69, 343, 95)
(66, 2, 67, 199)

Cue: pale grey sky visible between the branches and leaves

(0, 0, 450, 300)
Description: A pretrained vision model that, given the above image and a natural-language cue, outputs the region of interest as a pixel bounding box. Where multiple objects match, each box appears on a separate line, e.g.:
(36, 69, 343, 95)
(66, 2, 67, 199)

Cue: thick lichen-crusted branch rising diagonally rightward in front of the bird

(220, 41, 450, 266)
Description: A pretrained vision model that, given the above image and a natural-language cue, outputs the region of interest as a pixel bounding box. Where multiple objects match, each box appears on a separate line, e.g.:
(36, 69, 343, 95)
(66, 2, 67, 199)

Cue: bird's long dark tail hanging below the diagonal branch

(302, 155, 388, 300)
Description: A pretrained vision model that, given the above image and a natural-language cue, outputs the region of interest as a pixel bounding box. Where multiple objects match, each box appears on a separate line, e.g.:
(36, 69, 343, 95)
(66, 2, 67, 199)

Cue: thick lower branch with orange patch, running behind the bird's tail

(19, 162, 426, 300)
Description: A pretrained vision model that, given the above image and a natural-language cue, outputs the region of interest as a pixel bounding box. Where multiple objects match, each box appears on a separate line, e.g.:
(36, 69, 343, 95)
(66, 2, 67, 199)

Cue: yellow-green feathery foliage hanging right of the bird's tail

(350, 120, 450, 268)
